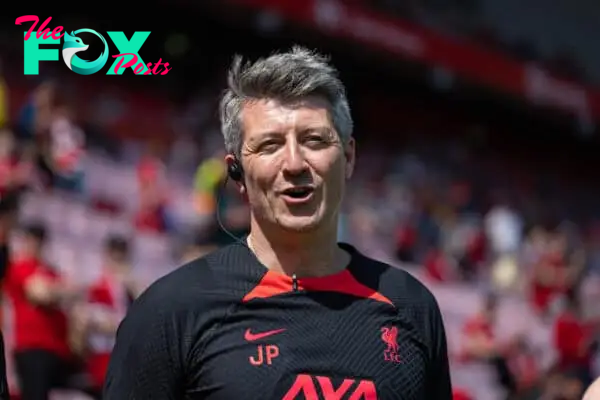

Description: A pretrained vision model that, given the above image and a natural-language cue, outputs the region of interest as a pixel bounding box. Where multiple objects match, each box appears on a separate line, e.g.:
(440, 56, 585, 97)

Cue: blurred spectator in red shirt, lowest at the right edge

(553, 291, 594, 387)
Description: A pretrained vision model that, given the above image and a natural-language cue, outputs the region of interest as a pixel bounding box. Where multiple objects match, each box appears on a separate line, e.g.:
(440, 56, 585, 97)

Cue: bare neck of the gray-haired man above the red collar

(248, 219, 350, 278)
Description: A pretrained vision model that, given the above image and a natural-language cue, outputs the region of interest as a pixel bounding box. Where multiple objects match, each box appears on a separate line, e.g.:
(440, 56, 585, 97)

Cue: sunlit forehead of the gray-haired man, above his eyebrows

(242, 96, 332, 139)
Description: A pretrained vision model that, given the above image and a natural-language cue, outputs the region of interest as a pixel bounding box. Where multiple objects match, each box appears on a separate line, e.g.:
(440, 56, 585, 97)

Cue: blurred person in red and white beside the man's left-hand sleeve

(80, 236, 140, 399)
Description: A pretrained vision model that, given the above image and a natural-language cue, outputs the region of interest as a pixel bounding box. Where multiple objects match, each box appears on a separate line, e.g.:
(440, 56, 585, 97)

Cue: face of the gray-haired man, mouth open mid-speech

(227, 97, 354, 232)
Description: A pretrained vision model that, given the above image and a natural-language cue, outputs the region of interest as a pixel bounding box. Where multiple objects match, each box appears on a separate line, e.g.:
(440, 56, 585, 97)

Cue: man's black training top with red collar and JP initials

(104, 244, 452, 400)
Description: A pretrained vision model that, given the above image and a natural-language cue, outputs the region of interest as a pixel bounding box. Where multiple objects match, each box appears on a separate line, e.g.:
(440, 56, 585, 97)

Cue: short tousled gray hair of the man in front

(220, 46, 353, 157)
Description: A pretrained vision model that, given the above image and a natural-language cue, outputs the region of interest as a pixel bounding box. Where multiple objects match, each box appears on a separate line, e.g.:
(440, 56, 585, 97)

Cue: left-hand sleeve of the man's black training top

(104, 284, 185, 400)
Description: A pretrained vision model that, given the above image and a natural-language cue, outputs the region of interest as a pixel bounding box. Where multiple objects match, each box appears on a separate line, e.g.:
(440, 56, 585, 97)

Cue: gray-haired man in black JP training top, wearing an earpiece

(104, 48, 452, 400)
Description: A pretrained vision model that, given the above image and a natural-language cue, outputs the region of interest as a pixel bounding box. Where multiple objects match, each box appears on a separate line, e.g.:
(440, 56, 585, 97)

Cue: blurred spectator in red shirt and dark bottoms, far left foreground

(5, 225, 82, 400)
